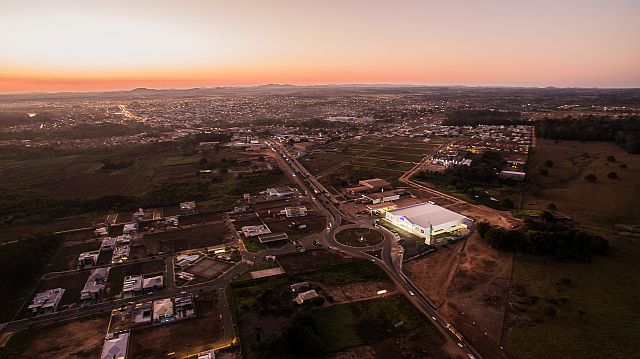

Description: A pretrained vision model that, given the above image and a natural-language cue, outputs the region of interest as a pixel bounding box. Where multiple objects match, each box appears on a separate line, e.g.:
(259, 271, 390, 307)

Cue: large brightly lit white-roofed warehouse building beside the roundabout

(385, 203, 472, 245)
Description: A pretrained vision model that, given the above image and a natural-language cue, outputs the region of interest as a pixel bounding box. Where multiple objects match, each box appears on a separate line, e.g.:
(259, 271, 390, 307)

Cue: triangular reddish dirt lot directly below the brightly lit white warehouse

(403, 242, 465, 306)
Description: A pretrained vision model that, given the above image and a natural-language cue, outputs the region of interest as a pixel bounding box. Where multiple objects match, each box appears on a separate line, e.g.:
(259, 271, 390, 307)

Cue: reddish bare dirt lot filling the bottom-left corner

(0, 314, 109, 359)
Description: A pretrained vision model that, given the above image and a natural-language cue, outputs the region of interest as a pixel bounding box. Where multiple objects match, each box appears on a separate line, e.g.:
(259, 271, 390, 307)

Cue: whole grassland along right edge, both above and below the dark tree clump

(504, 140, 640, 358)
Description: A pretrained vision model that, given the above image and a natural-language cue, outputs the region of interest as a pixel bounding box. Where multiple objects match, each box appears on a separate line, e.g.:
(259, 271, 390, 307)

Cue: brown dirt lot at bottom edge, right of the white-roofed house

(128, 293, 223, 358)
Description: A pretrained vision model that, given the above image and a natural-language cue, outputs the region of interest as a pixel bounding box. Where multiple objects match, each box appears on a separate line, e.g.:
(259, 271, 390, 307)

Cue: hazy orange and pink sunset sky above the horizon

(0, 0, 640, 93)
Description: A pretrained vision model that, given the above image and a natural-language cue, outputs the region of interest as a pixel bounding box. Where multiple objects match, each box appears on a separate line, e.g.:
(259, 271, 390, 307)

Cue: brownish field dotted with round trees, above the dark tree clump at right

(525, 139, 640, 226)
